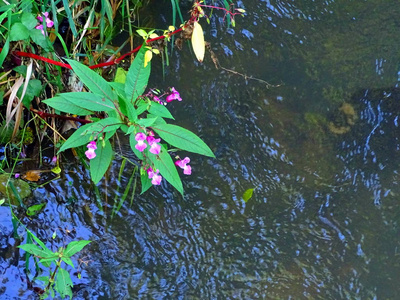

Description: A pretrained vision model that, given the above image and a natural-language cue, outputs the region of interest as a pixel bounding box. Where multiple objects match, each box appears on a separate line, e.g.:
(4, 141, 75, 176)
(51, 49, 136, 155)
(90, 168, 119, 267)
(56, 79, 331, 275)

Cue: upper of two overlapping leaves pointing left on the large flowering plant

(59, 92, 115, 111)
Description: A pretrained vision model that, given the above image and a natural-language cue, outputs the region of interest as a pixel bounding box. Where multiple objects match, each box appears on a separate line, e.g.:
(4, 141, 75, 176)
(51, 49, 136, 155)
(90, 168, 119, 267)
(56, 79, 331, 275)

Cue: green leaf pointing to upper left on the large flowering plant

(67, 59, 114, 101)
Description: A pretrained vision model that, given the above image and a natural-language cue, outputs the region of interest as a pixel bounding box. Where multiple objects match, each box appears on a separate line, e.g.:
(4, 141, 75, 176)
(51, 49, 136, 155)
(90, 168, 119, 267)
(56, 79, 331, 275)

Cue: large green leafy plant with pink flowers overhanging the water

(43, 42, 214, 194)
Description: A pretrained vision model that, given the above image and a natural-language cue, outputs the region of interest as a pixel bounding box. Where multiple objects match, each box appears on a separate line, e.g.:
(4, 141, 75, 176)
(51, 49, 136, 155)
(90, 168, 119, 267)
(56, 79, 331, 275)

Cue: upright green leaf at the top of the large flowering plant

(125, 44, 151, 104)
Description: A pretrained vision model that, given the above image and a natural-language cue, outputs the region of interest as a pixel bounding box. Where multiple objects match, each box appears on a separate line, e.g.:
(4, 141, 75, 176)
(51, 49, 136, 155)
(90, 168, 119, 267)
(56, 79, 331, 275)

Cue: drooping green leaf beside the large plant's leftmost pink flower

(90, 141, 113, 184)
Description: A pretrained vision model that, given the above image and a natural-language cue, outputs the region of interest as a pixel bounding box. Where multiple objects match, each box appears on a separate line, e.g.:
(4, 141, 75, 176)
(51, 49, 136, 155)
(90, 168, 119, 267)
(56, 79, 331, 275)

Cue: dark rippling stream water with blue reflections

(0, 0, 400, 299)
